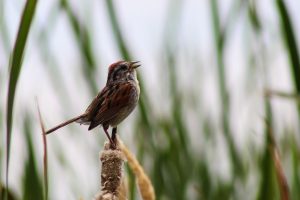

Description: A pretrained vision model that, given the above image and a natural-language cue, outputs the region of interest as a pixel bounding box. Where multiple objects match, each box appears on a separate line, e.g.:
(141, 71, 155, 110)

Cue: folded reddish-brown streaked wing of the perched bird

(89, 83, 135, 130)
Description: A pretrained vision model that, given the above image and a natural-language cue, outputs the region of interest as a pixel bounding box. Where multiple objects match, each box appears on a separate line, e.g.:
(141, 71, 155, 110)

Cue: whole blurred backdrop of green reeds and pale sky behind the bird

(0, 0, 300, 200)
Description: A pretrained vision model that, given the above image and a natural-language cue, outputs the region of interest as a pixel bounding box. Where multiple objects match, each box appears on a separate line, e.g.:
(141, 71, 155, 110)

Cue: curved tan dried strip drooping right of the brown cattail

(118, 140, 155, 200)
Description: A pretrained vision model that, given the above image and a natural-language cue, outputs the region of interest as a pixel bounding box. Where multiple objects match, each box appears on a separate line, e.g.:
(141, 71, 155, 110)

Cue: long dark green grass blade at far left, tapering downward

(6, 0, 37, 197)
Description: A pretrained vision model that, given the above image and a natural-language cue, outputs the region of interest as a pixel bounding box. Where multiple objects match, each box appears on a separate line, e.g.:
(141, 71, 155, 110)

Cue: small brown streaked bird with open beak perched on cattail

(45, 61, 141, 146)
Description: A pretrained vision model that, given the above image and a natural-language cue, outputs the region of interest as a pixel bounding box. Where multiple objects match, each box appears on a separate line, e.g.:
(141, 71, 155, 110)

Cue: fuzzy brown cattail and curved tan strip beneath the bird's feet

(95, 138, 155, 200)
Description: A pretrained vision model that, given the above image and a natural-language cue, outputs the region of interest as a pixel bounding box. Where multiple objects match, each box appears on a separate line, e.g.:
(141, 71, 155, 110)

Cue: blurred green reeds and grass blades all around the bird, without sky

(0, 0, 300, 200)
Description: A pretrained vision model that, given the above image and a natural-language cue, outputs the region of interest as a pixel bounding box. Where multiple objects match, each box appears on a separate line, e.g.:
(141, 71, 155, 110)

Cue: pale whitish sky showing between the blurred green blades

(0, 0, 300, 200)
